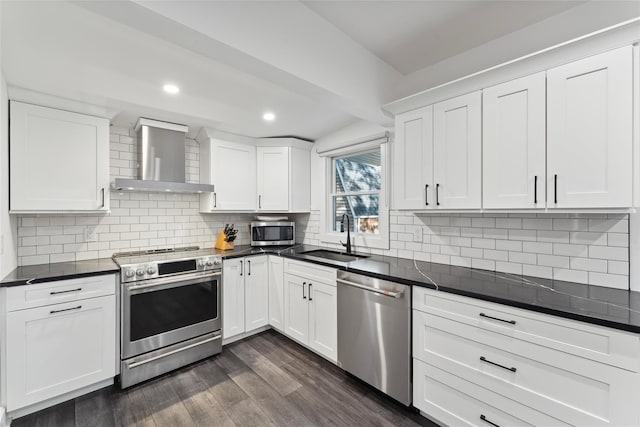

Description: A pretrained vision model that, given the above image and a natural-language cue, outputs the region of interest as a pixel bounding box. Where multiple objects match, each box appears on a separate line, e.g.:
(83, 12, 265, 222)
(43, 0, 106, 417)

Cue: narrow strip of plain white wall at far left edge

(0, 75, 18, 278)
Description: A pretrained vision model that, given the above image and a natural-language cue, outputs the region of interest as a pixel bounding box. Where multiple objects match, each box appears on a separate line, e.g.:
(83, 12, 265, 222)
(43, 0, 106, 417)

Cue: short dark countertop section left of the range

(0, 258, 120, 287)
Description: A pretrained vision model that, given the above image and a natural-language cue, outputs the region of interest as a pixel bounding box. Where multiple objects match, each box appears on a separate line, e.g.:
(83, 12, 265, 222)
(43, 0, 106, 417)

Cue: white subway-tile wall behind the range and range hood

(18, 127, 252, 265)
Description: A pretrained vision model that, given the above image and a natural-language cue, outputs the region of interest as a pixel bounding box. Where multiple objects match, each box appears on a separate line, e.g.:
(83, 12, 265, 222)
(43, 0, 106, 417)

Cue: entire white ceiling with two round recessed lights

(0, 0, 640, 139)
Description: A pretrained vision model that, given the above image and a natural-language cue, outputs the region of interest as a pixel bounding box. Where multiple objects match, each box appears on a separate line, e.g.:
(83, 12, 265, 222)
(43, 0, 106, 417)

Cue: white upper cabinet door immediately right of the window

(393, 106, 435, 209)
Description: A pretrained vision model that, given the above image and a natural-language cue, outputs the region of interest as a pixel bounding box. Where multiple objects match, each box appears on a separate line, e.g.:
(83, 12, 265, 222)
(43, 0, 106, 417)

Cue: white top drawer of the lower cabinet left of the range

(7, 274, 116, 311)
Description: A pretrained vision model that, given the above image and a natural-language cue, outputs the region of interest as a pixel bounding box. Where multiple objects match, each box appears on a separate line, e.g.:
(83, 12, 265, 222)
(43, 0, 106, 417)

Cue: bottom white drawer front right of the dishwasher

(413, 359, 570, 427)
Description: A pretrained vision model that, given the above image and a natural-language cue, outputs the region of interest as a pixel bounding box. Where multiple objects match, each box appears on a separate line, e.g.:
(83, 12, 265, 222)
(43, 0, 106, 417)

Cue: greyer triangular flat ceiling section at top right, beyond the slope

(304, 0, 585, 75)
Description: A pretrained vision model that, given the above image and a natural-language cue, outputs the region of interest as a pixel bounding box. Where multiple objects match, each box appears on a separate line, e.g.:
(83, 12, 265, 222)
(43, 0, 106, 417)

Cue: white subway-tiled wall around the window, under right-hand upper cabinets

(296, 118, 630, 289)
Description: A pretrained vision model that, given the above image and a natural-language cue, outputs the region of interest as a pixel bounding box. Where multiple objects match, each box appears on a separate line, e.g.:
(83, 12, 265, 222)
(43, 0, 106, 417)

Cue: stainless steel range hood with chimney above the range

(114, 118, 214, 193)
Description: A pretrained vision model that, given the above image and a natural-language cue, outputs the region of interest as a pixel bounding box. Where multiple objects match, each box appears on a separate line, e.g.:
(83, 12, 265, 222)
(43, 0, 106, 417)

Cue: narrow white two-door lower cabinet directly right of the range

(222, 255, 269, 339)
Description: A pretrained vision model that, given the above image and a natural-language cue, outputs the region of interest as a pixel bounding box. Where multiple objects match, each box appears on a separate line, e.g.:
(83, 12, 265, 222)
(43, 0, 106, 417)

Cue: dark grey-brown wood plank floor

(11, 330, 435, 427)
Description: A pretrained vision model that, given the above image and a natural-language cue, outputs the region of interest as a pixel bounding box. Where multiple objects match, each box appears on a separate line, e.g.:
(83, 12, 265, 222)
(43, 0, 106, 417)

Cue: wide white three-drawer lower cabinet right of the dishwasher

(413, 287, 640, 426)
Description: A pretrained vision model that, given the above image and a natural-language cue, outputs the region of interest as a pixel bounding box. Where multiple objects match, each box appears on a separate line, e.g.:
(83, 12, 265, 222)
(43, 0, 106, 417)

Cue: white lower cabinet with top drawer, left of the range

(4, 274, 119, 415)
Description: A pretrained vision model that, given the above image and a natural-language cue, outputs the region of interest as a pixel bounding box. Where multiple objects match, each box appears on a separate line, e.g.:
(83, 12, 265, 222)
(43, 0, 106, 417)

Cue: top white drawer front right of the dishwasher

(413, 286, 640, 372)
